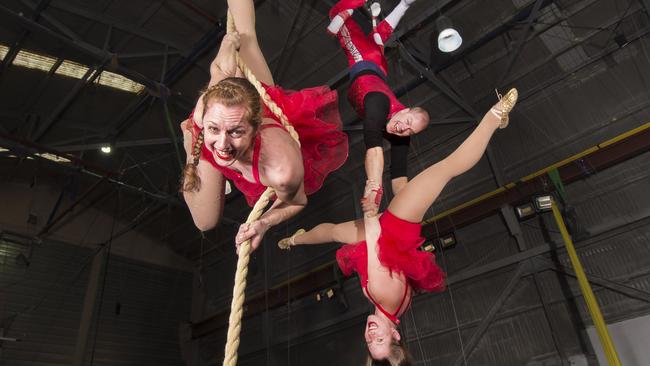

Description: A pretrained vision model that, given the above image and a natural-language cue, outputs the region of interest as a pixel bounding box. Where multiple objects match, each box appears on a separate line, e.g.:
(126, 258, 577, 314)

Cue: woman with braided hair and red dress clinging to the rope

(181, 0, 348, 250)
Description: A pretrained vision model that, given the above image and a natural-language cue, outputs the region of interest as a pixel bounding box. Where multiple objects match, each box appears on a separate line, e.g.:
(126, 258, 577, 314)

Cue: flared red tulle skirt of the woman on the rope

(262, 86, 348, 199)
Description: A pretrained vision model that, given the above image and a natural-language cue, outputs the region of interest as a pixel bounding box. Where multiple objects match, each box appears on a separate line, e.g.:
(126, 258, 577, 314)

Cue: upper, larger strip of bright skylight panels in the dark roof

(0, 44, 144, 94)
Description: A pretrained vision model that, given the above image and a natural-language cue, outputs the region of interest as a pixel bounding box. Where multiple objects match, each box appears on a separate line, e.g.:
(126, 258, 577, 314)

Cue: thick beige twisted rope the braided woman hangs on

(223, 11, 300, 366)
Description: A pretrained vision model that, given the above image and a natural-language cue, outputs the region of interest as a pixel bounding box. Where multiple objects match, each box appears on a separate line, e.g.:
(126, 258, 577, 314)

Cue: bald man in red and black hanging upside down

(327, 0, 429, 207)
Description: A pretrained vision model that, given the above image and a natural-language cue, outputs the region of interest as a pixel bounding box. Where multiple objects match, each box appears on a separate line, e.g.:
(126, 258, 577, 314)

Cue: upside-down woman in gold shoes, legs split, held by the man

(278, 89, 517, 366)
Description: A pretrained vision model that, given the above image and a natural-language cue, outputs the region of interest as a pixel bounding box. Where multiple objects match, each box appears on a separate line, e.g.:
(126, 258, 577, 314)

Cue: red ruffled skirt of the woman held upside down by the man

(336, 211, 445, 292)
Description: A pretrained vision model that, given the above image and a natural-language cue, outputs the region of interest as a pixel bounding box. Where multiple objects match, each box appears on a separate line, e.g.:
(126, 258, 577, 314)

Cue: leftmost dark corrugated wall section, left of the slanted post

(0, 236, 93, 366)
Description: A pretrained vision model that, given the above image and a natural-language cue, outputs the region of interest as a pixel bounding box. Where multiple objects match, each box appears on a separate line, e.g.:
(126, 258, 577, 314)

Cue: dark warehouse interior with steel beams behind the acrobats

(0, 0, 650, 366)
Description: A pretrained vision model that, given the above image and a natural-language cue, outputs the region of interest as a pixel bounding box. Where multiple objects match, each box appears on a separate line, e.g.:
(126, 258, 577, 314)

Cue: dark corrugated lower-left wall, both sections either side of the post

(0, 240, 191, 366)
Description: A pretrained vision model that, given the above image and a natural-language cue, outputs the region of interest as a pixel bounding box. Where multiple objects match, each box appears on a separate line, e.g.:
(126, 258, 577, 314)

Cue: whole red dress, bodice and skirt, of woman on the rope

(190, 85, 348, 206)
